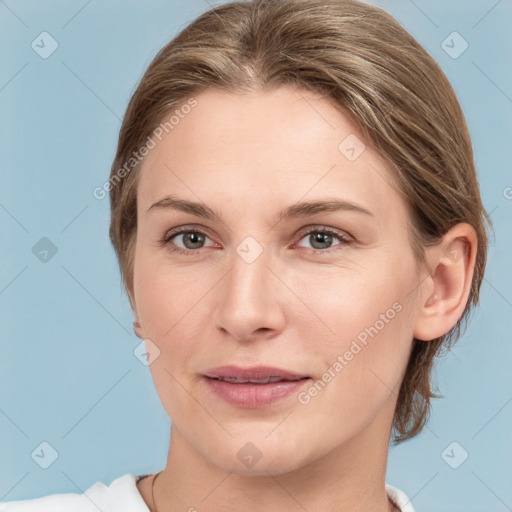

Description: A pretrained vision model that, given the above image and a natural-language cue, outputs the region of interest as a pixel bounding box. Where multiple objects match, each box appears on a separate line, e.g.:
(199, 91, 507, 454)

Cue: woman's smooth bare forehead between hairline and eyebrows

(138, 87, 405, 224)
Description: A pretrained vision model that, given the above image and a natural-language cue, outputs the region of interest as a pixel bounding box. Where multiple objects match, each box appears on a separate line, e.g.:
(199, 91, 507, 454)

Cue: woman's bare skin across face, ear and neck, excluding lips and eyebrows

(132, 87, 476, 512)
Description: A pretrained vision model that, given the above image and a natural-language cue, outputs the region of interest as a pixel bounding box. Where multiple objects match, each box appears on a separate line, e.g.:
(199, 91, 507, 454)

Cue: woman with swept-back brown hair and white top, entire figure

(0, 0, 487, 512)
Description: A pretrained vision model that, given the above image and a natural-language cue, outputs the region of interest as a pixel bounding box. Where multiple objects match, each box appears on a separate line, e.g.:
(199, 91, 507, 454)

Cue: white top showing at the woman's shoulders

(0, 473, 414, 512)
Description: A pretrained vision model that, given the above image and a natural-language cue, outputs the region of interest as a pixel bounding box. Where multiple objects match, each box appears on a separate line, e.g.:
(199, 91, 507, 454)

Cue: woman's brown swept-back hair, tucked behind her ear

(109, 0, 490, 444)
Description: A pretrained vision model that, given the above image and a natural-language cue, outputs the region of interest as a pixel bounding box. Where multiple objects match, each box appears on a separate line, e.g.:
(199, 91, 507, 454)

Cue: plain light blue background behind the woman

(0, 0, 512, 512)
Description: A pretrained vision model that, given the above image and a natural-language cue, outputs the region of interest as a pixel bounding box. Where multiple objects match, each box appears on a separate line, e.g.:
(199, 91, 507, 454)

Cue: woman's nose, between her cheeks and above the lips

(213, 245, 286, 342)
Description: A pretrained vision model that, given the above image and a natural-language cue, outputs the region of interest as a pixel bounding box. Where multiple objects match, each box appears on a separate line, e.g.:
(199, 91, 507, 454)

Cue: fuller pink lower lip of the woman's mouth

(205, 377, 310, 409)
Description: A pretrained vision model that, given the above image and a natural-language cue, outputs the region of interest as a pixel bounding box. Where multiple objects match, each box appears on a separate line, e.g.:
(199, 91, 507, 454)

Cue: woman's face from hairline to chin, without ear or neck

(134, 87, 420, 474)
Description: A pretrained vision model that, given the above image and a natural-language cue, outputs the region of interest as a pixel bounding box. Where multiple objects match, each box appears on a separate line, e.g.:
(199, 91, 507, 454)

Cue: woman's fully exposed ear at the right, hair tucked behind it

(414, 223, 478, 341)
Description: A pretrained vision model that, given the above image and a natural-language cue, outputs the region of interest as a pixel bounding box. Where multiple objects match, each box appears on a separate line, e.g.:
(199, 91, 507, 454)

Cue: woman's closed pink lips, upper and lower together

(203, 366, 311, 408)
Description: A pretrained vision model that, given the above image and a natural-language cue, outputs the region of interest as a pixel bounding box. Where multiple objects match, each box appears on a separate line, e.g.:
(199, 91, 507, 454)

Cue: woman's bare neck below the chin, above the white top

(155, 412, 396, 512)
